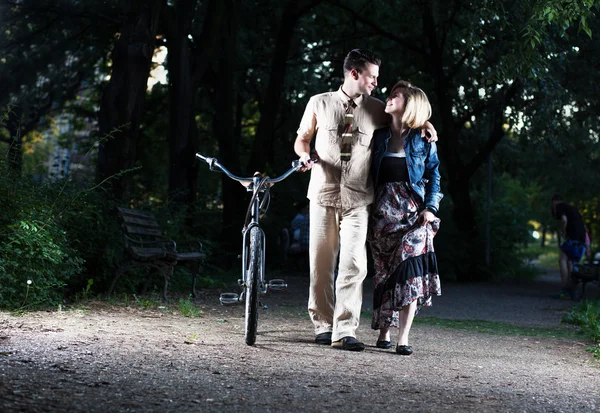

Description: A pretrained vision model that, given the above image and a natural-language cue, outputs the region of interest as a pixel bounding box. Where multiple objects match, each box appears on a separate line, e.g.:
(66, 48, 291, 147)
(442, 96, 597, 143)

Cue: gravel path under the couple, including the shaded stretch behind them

(0, 268, 600, 413)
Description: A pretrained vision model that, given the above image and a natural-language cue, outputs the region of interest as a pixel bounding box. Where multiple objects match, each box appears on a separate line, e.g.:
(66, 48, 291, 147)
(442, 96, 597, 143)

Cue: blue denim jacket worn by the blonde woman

(371, 127, 444, 214)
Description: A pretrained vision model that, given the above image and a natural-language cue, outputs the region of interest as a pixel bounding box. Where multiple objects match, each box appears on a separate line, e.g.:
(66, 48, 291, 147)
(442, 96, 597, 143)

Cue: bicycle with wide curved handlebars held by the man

(196, 153, 310, 346)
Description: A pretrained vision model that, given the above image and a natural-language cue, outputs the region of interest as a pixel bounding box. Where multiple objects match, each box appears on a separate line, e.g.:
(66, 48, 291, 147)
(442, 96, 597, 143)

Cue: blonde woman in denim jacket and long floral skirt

(369, 81, 443, 355)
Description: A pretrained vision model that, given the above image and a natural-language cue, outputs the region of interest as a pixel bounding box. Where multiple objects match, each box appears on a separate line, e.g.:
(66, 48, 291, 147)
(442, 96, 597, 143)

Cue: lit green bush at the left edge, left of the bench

(0, 155, 122, 310)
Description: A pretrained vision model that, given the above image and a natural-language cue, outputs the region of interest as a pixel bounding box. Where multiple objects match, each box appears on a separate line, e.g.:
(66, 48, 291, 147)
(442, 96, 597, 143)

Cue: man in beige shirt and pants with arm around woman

(294, 49, 437, 351)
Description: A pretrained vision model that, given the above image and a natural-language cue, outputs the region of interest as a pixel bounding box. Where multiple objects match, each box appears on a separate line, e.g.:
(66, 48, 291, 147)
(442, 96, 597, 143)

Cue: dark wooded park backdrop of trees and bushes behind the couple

(0, 0, 600, 310)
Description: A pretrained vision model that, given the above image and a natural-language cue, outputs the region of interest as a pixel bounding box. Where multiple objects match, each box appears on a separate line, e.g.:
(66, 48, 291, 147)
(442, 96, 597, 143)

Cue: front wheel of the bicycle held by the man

(246, 227, 264, 346)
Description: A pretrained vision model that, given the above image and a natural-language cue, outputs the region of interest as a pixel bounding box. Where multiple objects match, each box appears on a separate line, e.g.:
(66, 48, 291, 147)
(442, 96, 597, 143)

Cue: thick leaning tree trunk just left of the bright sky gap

(96, 0, 164, 198)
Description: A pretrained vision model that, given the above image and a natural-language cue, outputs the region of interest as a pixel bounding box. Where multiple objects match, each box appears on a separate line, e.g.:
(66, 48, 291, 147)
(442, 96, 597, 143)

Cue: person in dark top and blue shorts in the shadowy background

(552, 194, 587, 300)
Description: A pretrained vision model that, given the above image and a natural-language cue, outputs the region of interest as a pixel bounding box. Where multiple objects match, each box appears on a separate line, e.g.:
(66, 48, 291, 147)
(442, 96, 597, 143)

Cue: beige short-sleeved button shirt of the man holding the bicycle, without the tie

(298, 88, 389, 209)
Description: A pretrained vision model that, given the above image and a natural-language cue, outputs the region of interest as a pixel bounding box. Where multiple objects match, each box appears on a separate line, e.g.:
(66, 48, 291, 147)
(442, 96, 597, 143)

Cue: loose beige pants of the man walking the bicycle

(308, 202, 369, 341)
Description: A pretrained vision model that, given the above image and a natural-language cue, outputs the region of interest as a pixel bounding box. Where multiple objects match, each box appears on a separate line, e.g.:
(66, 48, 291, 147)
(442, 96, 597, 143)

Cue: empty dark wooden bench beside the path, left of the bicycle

(108, 208, 206, 301)
